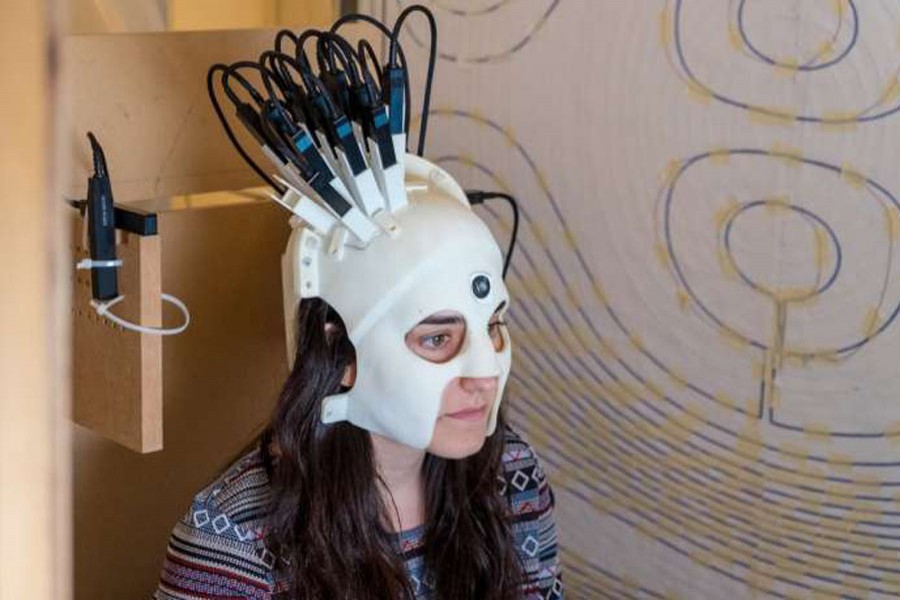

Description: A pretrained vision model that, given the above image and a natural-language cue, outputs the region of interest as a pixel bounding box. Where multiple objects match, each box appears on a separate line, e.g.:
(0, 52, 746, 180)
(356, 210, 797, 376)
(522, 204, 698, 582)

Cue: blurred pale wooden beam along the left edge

(0, 0, 72, 600)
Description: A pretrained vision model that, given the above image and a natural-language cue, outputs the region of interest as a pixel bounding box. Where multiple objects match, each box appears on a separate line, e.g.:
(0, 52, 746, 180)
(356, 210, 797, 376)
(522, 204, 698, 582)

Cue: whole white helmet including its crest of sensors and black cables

(207, 5, 515, 448)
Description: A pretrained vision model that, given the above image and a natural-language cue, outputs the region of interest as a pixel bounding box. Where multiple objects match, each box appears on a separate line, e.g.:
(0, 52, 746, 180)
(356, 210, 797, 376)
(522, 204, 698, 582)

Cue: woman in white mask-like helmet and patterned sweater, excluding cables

(156, 157, 562, 600)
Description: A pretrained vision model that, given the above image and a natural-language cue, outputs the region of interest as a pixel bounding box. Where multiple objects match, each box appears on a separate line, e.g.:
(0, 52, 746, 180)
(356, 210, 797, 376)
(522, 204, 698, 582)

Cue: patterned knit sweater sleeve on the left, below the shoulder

(153, 496, 274, 600)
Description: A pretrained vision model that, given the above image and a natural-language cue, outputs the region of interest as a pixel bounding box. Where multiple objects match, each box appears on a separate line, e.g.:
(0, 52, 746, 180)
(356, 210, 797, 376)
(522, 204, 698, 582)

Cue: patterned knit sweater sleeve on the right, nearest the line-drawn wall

(501, 430, 563, 600)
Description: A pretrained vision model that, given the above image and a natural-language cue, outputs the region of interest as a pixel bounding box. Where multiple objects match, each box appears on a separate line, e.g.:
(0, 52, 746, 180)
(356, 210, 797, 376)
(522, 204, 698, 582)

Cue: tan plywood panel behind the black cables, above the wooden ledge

(64, 30, 288, 203)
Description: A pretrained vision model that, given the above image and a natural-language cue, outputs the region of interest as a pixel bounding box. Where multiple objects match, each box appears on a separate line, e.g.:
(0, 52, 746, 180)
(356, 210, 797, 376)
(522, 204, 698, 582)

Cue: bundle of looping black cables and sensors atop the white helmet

(207, 5, 437, 245)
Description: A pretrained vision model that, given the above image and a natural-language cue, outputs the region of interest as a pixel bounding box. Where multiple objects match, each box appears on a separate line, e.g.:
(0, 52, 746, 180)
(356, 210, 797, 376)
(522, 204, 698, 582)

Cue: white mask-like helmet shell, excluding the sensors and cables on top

(282, 155, 511, 448)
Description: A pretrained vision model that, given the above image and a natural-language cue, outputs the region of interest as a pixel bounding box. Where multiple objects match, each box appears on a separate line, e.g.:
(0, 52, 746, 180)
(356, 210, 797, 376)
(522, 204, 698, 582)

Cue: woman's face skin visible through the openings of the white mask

(405, 303, 506, 459)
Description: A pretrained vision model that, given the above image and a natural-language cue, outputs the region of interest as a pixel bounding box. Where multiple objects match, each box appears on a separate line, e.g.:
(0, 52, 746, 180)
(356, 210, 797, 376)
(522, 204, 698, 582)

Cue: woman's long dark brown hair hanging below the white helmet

(260, 299, 522, 600)
